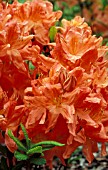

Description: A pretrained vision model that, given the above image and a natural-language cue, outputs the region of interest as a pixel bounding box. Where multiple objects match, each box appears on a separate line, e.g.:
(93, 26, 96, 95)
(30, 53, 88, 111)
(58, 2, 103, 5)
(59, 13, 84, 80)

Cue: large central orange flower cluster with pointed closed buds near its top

(25, 59, 108, 162)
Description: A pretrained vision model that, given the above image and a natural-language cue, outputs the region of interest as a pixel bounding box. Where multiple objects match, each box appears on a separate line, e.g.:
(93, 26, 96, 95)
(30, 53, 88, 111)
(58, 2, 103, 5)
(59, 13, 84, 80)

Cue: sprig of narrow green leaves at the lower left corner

(0, 124, 64, 170)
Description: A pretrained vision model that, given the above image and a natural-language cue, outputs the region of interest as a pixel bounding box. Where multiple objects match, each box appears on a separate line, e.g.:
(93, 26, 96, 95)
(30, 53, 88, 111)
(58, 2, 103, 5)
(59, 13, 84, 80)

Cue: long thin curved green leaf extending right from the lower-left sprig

(32, 141, 65, 148)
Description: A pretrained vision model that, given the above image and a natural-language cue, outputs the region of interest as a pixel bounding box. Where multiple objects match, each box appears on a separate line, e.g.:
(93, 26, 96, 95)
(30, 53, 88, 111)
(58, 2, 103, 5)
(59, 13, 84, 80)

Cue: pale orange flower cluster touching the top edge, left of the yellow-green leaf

(12, 0, 62, 45)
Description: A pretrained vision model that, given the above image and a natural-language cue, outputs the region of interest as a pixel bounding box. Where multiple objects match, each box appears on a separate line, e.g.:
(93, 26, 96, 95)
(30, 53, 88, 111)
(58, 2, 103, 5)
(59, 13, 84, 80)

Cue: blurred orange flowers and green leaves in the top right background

(54, 0, 108, 42)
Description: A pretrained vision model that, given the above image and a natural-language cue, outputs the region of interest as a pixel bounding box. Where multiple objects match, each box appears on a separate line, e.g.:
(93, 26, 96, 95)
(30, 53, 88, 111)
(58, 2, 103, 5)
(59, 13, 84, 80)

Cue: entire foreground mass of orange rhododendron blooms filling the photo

(0, 0, 108, 167)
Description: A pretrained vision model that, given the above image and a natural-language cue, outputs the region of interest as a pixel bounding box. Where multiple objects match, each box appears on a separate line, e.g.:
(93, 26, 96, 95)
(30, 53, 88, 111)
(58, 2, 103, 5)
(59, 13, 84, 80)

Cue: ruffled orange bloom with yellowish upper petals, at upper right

(51, 17, 105, 70)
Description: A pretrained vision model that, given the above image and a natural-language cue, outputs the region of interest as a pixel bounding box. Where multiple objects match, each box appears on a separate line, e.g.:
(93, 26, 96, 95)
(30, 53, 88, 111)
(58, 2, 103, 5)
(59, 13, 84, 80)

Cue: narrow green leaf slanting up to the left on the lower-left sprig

(8, 129, 27, 152)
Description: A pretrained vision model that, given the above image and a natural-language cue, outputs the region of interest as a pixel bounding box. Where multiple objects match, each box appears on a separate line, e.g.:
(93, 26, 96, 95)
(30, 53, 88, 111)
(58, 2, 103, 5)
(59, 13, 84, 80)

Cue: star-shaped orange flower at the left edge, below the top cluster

(0, 22, 33, 72)
